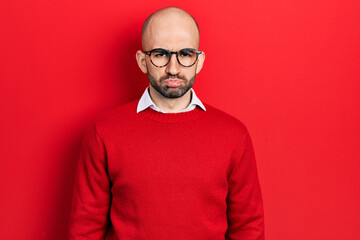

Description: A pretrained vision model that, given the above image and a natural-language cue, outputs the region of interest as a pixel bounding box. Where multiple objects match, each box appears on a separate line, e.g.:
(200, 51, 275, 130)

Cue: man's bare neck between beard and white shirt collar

(149, 85, 191, 113)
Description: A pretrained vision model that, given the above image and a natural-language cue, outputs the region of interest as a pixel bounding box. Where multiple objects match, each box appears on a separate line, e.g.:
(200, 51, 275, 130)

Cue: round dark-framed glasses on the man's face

(145, 48, 202, 68)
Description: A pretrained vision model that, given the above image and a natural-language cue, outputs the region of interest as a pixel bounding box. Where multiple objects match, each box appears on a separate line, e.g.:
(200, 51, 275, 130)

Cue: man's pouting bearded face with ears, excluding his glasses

(137, 9, 204, 98)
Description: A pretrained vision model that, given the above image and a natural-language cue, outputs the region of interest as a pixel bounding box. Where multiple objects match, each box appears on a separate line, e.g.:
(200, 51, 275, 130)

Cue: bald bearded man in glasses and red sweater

(70, 7, 264, 240)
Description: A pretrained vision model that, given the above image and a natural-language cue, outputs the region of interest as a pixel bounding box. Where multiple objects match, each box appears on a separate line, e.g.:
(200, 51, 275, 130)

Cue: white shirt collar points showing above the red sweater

(136, 87, 206, 113)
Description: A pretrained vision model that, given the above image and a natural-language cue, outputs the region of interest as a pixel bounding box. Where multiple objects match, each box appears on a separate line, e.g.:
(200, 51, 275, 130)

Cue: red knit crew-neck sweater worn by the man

(70, 101, 264, 240)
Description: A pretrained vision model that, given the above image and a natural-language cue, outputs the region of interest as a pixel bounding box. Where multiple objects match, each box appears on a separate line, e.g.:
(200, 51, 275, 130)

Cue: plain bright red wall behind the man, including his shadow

(0, 0, 360, 240)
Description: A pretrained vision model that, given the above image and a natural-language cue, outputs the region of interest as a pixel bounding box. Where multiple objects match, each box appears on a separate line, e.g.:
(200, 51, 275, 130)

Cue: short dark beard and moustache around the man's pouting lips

(148, 71, 196, 98)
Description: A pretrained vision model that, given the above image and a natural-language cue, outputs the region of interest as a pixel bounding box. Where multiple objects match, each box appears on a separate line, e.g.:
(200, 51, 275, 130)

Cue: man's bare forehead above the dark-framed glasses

(143, 11, 199, 51)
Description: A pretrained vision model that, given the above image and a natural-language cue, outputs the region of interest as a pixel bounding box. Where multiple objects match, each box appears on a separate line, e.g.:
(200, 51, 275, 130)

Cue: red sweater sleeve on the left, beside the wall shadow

(69, 124, 111, 240)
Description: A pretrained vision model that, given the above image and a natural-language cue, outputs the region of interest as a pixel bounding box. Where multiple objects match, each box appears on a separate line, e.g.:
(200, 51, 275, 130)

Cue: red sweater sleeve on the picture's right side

(226, 130, 264, 240)
